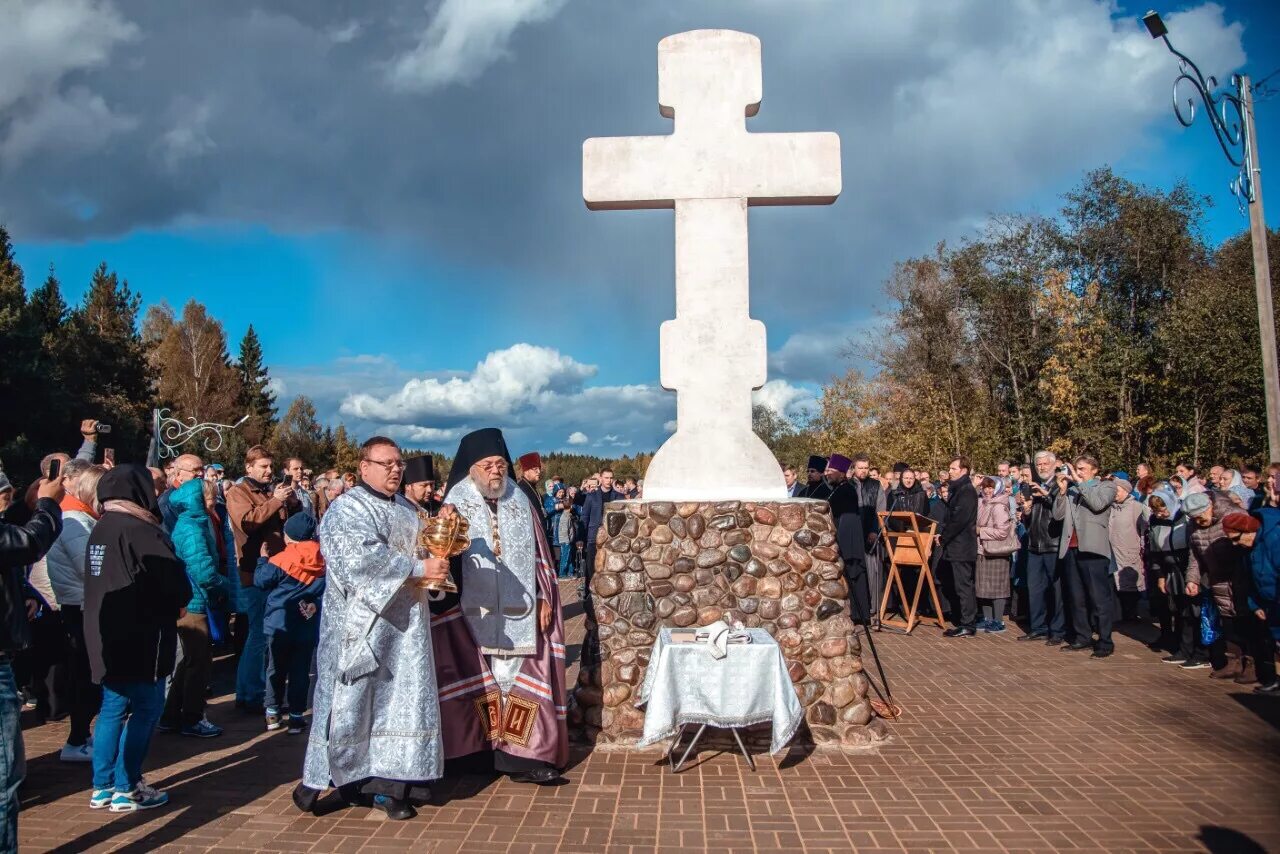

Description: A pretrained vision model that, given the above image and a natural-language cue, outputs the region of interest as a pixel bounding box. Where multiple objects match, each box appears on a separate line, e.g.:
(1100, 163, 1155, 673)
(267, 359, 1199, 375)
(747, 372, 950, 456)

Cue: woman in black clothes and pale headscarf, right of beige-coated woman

(1143, 486, 1207, 665)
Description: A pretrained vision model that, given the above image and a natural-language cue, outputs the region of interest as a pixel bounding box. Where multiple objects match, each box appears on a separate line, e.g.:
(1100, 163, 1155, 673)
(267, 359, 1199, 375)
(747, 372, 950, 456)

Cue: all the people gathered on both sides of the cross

(0, 420, 1280, 849)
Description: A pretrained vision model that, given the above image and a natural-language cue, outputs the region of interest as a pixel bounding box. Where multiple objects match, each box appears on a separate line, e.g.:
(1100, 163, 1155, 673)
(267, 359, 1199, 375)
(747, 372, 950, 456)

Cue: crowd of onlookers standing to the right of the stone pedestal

(783, 451, 1280, 697)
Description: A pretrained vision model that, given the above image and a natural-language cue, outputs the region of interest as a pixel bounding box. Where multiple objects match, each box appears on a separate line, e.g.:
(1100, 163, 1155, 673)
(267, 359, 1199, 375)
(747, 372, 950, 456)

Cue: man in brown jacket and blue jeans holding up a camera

(227, 444, 302, 713)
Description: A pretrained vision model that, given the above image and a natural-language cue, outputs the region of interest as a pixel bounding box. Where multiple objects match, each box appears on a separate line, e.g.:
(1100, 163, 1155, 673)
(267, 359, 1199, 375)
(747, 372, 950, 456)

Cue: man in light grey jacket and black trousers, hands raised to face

(1053, 457, 1116, 658)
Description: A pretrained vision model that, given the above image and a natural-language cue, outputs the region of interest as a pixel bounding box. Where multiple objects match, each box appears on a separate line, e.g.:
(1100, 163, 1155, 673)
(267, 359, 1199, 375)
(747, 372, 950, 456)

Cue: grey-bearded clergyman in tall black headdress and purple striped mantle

(431, 428, 568, 786)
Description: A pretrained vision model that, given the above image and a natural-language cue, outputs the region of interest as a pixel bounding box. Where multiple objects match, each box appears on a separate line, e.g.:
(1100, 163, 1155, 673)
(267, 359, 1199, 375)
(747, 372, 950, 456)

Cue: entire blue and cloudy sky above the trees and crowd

(0, 0, 1280, 453)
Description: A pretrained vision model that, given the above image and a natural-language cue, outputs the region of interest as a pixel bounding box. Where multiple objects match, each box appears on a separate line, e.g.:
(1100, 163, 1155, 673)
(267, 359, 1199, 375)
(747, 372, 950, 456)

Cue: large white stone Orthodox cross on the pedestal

(582, 29, 840, 501)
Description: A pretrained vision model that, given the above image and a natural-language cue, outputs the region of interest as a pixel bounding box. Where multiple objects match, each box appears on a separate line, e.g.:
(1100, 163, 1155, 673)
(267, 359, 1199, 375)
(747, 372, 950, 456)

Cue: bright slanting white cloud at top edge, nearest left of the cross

(388, 0, 566, 91)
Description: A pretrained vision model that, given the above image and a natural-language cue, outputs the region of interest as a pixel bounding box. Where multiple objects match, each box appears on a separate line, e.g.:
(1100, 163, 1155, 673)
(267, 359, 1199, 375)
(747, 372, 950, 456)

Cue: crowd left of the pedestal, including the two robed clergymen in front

(0, 420, 573, 834)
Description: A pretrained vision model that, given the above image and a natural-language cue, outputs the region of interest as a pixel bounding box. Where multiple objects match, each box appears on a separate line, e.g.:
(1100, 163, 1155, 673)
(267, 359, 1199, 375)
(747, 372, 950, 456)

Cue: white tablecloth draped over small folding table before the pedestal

(636, 629, 804, 753)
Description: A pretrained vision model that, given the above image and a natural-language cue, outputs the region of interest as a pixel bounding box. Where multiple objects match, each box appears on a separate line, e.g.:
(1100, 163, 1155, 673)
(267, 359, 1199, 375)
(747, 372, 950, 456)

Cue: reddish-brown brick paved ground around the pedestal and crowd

(12, 583, 1280, 854)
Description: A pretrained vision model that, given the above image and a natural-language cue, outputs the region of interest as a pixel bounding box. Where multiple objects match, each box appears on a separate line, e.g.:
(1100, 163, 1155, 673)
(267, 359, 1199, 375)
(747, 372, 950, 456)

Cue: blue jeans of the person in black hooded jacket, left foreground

(93, 680, 164, 791)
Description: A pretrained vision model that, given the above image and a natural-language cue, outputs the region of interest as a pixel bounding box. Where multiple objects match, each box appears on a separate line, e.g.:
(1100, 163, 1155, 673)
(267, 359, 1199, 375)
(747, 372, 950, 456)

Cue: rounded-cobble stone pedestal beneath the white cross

(571, 499, 886, 748)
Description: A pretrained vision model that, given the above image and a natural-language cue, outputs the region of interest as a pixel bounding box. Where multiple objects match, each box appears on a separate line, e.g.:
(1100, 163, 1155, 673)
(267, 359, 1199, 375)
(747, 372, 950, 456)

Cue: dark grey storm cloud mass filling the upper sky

(0, 0, 1243, 326)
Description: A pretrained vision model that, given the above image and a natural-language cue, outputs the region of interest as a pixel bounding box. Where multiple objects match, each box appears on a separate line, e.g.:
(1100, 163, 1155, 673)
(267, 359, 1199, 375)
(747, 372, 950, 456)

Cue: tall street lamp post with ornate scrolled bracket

(1142, 12, 1280, 461)
